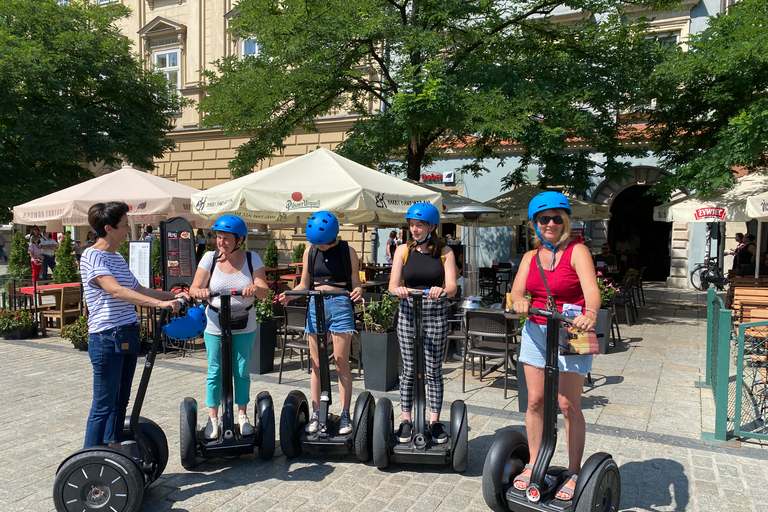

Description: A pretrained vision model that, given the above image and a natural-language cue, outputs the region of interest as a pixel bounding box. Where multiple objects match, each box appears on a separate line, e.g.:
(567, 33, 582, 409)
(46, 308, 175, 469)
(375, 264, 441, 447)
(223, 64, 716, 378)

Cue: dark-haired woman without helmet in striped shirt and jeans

(80, 201, 190, 448)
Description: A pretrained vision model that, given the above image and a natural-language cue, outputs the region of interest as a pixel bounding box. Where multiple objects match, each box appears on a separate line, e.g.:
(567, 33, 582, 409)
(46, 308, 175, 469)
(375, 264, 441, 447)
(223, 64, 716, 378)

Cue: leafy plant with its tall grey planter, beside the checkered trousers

(360, 293, 400, 391)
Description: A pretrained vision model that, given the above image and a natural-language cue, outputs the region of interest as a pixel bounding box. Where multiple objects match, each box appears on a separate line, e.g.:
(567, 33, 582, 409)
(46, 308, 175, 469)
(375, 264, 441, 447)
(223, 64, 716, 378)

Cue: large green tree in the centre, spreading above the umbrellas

(200, 0, 669, 189)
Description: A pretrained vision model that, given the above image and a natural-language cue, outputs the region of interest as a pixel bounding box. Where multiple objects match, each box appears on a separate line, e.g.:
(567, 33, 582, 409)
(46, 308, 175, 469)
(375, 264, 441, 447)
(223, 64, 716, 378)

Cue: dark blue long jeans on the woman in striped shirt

(83, 329, 139, 448)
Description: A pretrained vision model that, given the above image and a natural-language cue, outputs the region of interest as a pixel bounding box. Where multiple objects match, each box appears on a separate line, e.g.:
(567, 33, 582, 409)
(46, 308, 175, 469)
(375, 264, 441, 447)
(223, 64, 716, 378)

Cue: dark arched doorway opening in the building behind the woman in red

(607, 184, 672, 281)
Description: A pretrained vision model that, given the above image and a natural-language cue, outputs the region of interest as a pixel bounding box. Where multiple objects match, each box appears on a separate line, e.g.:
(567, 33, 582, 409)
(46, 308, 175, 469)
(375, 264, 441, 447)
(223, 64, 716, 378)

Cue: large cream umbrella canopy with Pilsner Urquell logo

(192, 148, 442, 226)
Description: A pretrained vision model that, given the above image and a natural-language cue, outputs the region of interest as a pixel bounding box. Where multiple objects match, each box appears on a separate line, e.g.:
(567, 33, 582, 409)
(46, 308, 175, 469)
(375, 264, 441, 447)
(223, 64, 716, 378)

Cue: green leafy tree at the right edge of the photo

(649, 0, 768, 198)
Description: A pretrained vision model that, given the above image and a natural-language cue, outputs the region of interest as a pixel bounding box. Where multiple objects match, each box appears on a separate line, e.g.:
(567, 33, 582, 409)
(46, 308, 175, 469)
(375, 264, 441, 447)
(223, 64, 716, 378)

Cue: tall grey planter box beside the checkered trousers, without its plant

(360, 331, 400, 391)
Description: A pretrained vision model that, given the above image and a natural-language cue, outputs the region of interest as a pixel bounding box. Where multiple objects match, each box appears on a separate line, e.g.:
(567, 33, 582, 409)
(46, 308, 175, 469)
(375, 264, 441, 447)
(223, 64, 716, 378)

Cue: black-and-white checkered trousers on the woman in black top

(397, 298, 448, 413)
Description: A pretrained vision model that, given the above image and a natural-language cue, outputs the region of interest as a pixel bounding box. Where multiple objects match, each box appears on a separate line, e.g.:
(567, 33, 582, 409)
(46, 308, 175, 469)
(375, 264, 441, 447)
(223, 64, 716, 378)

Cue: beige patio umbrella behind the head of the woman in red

(478, 185, 611, 226)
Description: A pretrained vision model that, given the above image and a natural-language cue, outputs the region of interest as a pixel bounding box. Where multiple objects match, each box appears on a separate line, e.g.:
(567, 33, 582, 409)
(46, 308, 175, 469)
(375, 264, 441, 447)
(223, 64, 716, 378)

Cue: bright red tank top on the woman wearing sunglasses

(525, 241, 586, 324)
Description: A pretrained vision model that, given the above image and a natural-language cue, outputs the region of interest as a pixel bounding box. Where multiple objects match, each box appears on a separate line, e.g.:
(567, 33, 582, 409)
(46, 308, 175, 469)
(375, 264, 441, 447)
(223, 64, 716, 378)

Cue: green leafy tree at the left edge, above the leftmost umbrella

(0, 0, 182, 221)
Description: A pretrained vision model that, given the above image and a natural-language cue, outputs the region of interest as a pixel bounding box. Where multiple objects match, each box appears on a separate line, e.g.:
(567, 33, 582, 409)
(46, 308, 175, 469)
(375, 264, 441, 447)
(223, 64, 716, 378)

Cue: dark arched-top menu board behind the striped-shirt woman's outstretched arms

(160, 217, 197, 290)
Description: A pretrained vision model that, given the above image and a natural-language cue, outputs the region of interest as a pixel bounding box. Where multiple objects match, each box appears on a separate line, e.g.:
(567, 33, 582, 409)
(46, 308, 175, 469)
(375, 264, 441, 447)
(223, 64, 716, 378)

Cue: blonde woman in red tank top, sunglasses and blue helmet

(511, 192, 600, 501)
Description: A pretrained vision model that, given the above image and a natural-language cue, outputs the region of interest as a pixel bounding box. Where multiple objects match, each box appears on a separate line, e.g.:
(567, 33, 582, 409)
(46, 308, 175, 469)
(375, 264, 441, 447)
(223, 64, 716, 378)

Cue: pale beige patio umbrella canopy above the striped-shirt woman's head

(13, 166, 203, 227)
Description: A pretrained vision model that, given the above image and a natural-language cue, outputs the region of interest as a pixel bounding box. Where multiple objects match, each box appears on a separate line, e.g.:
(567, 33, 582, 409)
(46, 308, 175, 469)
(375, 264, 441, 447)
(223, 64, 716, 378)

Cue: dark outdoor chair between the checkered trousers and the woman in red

(461, 309, 520, 399)
